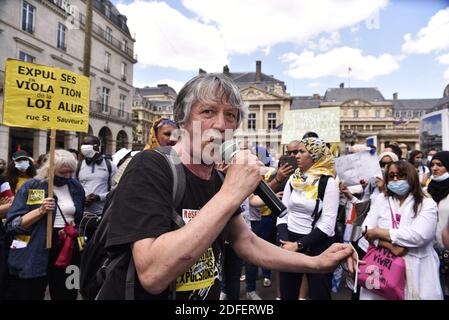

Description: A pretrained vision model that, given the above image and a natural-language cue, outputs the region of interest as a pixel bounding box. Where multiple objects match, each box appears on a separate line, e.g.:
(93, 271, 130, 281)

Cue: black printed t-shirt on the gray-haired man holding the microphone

(100, 151, 229, 300)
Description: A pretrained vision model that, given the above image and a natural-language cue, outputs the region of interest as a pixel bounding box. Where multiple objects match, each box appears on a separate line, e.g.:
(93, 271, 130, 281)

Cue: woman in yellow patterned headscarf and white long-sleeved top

(277, 138, 339, 300)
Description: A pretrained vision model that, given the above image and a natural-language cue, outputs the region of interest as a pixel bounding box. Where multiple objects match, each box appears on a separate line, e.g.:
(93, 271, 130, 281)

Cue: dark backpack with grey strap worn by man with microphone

(80, 147, 186, 300)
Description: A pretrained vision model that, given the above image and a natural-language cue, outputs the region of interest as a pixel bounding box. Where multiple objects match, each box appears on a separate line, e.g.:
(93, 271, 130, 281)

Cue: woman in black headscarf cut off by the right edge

(427, 151, 449, 296)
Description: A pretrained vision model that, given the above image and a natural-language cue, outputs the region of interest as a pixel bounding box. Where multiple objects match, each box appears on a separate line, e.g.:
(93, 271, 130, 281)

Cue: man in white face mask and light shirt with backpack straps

(76, 136, 117, 220)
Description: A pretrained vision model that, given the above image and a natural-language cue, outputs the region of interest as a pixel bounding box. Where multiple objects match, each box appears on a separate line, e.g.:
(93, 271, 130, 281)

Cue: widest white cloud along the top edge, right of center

(182, 0, 388, 54)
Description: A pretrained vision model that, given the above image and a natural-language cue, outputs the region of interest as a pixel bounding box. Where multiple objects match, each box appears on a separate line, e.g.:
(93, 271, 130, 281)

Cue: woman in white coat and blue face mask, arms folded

(360, 161, 443, 300)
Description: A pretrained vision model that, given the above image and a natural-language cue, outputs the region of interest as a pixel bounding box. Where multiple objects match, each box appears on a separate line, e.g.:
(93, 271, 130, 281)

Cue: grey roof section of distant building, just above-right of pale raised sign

(323, 88, 385, 102)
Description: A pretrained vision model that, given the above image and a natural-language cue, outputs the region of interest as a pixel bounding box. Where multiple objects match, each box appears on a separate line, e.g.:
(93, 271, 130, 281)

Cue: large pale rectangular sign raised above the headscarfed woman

(281, 107, 340, 144)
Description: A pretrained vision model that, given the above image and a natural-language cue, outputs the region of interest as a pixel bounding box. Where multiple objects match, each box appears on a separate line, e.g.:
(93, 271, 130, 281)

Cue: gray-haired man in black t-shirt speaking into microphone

(99, 74, 352, 300)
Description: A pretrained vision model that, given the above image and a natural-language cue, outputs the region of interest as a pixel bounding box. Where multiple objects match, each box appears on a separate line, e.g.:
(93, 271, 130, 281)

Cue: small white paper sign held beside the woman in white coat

(335, 151, 382, 186)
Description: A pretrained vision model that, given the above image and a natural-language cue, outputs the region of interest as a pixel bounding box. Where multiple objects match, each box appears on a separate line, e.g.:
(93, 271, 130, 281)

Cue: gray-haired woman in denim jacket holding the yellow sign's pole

(6, 150, 85, 300)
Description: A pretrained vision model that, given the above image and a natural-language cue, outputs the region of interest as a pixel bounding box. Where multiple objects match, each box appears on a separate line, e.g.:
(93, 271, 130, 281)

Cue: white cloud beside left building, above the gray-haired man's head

(116, 0, 229, 71)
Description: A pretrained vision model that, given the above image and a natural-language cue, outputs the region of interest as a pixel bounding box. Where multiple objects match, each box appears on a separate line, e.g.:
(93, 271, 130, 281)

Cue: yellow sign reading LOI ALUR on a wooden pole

(3, 59, 90, 132)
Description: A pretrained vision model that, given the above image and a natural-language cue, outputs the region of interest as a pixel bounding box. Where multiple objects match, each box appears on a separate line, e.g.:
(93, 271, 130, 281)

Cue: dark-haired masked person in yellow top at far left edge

(5, 150, 36, 194)
